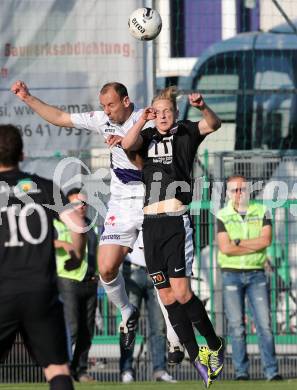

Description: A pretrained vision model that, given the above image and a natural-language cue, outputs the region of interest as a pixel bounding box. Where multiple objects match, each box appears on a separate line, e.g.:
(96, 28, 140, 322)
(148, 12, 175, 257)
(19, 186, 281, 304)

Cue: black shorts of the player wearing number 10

(0, 291, 70, 367)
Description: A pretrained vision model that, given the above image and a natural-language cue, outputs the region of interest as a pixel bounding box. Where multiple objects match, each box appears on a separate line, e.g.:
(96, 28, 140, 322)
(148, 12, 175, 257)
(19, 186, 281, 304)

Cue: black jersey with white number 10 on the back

(0, 170, 66, 295)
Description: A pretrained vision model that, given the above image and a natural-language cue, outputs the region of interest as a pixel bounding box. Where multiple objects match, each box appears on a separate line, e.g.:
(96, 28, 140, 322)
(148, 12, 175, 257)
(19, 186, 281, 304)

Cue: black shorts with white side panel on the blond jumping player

(143, 213, 194, 289)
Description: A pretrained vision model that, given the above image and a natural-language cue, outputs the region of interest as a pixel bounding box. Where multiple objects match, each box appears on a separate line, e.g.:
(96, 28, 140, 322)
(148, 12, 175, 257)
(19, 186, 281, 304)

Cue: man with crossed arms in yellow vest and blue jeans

(217, 175, 282, 380)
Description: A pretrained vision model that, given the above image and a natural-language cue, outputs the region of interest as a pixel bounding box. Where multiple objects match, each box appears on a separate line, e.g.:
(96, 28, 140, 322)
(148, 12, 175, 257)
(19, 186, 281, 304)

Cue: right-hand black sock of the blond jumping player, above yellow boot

(181, 294, 221, 350)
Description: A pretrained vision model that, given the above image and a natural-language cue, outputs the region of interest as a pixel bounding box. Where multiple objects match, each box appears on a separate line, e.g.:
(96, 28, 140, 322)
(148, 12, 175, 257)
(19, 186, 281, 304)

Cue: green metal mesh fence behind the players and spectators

(0, 152, 297, 382)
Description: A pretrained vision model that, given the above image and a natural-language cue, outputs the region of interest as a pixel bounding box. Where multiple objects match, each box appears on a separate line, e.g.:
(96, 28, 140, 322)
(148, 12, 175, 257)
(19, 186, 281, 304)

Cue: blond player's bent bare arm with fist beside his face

(122, 107, 156, 151)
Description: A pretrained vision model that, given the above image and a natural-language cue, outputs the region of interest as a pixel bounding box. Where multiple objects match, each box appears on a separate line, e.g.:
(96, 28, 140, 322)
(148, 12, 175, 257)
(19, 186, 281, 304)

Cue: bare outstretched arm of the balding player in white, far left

(11, 80, 74, 127)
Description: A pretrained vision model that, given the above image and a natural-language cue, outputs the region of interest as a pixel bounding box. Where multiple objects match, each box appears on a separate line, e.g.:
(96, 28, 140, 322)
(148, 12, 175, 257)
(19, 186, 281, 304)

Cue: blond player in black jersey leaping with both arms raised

(122, 87, 224, 387)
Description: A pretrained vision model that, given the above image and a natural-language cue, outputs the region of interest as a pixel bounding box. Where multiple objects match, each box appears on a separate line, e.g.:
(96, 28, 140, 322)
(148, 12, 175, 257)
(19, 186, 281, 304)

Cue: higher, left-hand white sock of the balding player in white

(100, 272, 133, 323)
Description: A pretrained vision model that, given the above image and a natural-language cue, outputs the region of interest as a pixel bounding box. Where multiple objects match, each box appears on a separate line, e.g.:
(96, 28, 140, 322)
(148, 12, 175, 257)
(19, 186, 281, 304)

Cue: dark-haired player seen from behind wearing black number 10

(0, 125, 85, 390)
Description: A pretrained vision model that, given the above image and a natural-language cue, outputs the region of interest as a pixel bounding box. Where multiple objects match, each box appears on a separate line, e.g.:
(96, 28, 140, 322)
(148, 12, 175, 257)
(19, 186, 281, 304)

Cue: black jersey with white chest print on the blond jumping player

(140, 120, 205, 206)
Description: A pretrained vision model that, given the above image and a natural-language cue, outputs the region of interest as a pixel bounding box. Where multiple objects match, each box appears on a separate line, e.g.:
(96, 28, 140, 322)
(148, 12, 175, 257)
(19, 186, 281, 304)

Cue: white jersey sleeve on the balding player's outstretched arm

(70, 111, 106, 134)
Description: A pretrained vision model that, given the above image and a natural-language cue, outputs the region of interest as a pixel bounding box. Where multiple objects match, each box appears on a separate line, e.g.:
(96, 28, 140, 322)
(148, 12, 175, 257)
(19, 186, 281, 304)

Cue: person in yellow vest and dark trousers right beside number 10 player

(54, 188, 98, 382)
